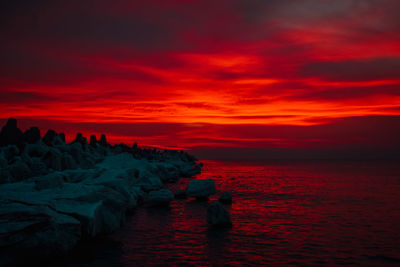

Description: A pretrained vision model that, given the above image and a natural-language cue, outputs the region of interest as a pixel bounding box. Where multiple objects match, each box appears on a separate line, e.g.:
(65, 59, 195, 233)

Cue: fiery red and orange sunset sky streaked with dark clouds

(0, 0, 400, 159)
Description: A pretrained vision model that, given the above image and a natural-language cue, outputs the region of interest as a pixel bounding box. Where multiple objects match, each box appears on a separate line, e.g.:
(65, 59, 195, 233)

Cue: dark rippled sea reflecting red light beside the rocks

(61, 161, 400, 266)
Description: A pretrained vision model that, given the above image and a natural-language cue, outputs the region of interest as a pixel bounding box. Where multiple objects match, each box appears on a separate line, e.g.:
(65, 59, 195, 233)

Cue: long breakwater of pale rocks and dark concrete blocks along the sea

(0, 119, 201, 266)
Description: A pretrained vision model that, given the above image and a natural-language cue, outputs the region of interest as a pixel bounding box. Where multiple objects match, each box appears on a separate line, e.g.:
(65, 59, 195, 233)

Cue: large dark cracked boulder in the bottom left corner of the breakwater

(0, 201, 81, 266)
